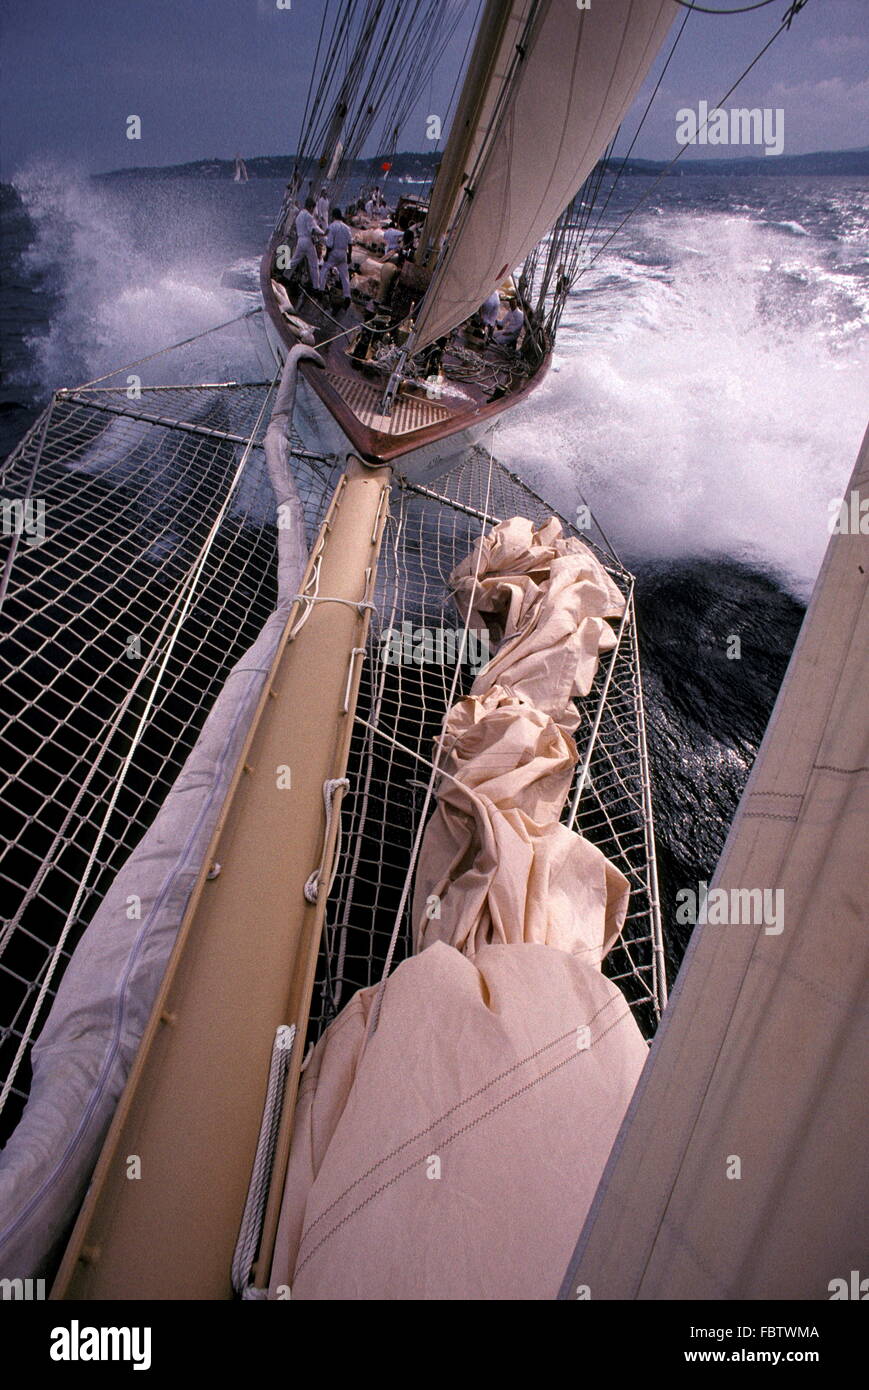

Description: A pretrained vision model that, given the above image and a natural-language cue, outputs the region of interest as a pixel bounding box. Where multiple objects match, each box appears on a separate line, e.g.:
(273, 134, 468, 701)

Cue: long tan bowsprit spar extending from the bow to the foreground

(53, 459, 389, 1298)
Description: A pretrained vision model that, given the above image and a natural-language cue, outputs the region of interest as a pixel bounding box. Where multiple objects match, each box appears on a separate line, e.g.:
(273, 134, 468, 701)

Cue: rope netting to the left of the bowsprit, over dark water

(0, 382, 335, 1136)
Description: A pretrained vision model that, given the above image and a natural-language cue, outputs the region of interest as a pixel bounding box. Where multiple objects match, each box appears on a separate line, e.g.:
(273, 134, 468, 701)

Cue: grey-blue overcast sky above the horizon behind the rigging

(0, 0, 869, 179)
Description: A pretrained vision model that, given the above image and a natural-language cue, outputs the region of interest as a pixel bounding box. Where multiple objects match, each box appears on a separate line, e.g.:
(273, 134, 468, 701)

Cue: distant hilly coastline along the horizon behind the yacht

(95, 147, 869, 182)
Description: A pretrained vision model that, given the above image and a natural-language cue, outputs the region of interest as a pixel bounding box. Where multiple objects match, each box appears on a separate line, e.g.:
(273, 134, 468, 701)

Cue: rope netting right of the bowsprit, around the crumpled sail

(310, 450, 666, 1038)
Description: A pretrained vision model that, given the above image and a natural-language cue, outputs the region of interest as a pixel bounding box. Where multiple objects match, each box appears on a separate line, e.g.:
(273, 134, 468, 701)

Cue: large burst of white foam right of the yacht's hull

(496, 214, 869, 596)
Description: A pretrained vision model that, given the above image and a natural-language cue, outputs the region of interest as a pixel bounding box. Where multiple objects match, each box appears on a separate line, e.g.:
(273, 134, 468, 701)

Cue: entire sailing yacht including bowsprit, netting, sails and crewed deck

(0, 0, 869, 1301)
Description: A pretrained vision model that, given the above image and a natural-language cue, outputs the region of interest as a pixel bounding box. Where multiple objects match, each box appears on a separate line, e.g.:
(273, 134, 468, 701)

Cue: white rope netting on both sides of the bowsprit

(0, 364, 665, 1140)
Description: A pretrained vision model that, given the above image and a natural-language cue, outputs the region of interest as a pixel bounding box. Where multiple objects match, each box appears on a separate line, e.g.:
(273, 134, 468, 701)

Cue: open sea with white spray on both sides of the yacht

(0, 165, 869, 963)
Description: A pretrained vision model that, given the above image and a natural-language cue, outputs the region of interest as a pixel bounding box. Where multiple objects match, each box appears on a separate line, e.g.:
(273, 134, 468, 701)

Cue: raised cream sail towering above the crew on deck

(414, 0, 677, 348)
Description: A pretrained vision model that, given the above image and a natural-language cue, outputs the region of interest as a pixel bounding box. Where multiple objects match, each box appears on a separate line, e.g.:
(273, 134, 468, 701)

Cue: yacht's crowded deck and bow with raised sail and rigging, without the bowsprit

(261, 0, 674, 470)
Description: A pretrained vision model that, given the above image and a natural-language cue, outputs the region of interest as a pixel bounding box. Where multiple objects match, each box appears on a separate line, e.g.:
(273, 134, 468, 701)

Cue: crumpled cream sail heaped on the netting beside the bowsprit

(271, 517, 648, 1300)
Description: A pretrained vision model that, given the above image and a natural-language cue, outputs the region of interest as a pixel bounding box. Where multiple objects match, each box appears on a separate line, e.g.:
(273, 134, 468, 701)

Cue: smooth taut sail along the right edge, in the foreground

(562, 431, 869, 1300)
